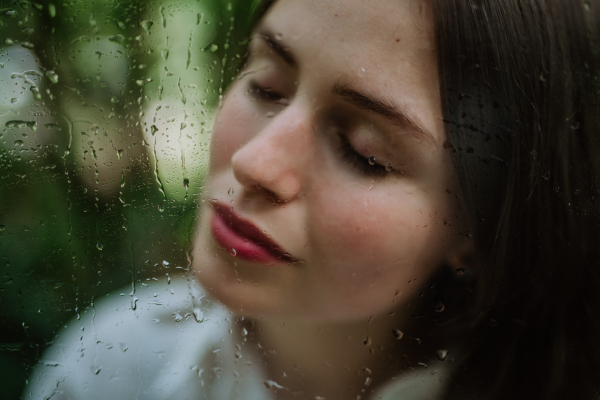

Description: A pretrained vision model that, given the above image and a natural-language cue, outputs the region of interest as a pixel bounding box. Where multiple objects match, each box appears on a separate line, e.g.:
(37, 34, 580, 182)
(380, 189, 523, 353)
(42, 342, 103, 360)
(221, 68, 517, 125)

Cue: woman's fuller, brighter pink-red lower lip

(211, 213, 283, 263)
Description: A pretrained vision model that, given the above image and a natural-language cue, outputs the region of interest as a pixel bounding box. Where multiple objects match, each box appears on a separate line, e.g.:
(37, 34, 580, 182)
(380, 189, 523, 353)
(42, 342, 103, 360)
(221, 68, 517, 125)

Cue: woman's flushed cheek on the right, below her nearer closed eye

(311, 183, 446, 293)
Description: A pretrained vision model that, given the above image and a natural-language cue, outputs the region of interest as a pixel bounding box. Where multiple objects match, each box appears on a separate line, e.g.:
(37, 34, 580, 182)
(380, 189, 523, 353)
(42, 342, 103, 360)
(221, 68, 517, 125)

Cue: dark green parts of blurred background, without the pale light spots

(0, 0, 260, 399)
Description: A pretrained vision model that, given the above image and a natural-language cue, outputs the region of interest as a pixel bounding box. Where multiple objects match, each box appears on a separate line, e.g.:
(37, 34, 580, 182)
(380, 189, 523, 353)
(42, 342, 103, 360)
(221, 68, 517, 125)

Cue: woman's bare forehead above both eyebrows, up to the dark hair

(258, 0, 442, 142)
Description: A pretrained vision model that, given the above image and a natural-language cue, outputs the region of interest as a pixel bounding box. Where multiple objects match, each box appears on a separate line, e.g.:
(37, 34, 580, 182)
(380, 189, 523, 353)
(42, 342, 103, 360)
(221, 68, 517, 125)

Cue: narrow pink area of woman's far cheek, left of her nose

(211, 94, 258, 170)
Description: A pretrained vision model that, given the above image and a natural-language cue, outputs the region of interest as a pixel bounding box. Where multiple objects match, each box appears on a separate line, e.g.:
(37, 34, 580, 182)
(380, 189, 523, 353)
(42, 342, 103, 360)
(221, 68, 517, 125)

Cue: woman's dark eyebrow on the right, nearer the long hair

(333, 82, 437, 145)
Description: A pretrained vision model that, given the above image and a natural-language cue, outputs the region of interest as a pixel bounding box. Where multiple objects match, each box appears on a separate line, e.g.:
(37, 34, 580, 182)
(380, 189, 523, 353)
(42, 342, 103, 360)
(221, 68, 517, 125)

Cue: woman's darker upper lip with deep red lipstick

(212, 202, 297, 262)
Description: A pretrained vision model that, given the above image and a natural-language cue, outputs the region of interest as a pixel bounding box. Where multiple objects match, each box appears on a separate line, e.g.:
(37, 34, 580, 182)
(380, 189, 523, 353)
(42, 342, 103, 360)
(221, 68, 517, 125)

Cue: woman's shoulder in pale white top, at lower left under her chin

(24, 278, 229, 399)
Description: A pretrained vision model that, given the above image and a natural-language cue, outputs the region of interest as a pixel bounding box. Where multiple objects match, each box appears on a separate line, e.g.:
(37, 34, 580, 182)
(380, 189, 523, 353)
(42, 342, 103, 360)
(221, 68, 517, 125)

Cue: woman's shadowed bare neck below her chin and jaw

(239, 311, 442, 400)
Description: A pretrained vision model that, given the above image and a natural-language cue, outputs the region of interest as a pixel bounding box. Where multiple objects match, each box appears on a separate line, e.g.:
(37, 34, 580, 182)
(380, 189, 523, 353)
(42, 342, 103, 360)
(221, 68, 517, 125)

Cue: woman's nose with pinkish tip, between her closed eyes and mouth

(231, 105, 312, 202)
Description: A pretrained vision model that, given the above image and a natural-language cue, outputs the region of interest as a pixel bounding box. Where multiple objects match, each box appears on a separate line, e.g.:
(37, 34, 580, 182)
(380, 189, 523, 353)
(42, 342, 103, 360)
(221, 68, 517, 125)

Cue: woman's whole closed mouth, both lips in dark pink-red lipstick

(211, 202, 295, 263)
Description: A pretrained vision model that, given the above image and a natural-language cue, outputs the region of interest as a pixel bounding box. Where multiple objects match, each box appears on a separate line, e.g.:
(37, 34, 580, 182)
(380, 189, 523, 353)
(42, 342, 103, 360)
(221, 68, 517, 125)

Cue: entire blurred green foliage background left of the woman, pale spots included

(0, 0, 261, 399)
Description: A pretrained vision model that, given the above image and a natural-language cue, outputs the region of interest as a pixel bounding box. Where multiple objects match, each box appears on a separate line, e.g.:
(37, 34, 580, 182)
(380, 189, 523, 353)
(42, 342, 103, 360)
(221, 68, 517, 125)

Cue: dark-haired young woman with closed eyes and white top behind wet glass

(21, 0, 600, 399)
